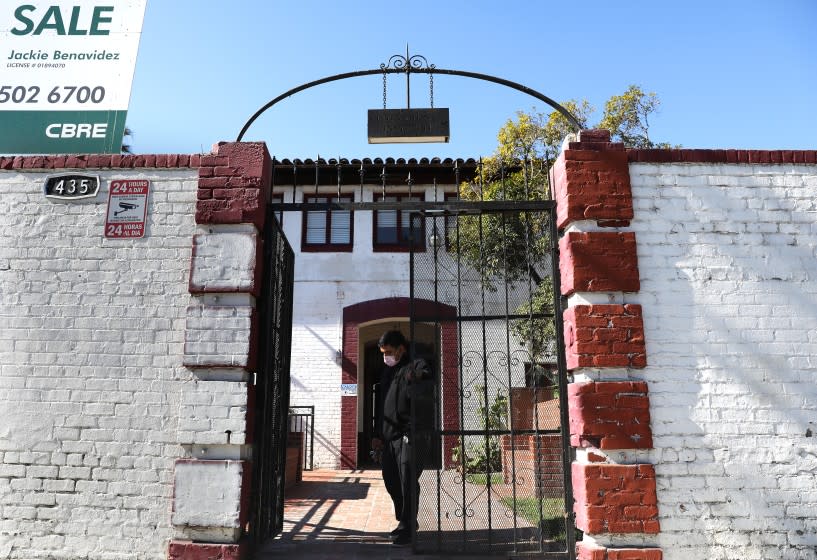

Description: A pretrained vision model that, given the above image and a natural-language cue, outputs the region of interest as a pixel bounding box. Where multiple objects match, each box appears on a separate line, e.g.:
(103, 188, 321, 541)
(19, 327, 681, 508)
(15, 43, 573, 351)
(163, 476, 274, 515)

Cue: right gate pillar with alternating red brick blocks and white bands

(551, 130, 662, 560)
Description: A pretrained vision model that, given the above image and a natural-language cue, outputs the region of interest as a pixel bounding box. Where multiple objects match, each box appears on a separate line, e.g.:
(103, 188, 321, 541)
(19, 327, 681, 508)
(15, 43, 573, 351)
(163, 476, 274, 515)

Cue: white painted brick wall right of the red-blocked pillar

(627, 164, 817, 560)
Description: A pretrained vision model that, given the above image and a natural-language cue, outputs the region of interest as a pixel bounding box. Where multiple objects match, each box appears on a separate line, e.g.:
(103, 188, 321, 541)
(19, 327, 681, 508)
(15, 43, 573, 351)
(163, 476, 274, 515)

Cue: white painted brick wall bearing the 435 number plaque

(0, 169, 197, 560)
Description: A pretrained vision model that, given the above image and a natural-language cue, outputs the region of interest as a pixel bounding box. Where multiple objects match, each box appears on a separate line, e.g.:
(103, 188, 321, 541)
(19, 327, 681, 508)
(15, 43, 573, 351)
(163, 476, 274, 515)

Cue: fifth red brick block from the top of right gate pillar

(572, 463, 659, 534)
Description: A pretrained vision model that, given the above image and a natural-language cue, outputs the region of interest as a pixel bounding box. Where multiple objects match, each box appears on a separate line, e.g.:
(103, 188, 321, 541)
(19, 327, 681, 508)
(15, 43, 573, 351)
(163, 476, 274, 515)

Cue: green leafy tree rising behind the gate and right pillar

(452, 85, 667, 361)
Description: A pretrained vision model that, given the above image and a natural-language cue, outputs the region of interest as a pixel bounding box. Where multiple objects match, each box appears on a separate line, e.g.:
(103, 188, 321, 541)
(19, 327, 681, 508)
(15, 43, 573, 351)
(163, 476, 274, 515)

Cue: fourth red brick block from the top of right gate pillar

(567, 381, 652, 449)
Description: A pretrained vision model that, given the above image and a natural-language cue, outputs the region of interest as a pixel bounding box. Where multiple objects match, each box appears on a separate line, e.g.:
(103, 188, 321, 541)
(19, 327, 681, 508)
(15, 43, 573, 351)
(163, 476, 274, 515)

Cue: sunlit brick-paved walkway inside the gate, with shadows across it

(256, 470, 548, 560)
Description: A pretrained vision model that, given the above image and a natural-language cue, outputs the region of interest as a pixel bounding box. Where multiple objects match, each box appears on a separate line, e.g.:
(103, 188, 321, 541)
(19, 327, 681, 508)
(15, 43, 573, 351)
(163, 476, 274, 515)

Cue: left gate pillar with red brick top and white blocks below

(167, 143, 270, 560)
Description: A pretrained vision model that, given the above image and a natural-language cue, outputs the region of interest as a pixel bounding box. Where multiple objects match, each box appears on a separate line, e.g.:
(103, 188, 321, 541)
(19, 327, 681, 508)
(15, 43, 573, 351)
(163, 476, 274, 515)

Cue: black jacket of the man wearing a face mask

(381, 357, 434, 441)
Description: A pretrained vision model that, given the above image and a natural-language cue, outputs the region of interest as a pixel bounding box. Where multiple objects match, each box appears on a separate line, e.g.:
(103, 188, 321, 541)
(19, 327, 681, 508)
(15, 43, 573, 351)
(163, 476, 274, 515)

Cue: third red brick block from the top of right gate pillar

(563, 304, 647, 369)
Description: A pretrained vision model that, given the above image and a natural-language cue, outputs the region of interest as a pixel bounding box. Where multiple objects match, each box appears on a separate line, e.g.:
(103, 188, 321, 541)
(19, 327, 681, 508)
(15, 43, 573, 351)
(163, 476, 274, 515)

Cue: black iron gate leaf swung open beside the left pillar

(250, 210, 295, 545)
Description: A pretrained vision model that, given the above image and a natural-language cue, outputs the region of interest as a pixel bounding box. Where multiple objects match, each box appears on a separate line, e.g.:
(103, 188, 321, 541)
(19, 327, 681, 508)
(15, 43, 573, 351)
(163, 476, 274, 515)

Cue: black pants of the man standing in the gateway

(383, 438, 422, 534)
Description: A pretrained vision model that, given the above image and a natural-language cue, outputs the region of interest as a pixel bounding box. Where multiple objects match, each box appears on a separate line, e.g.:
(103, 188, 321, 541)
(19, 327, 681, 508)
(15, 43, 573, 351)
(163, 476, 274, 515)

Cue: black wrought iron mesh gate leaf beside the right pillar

(411, 201, 575, 559)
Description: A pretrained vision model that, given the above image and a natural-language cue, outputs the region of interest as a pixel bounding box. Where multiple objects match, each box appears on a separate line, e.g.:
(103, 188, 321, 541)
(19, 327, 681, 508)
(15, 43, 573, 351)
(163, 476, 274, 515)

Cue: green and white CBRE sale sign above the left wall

(0, 0, 147, 154)
